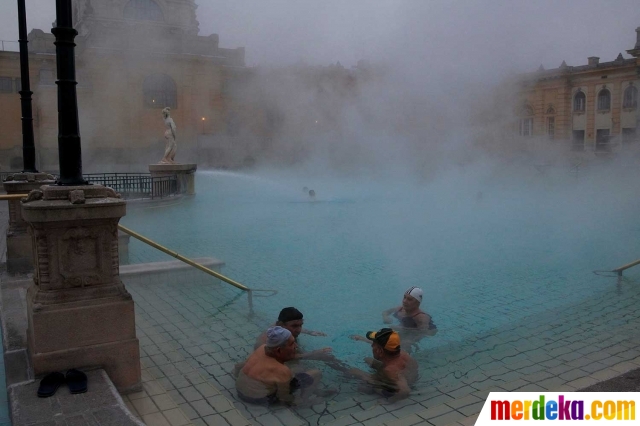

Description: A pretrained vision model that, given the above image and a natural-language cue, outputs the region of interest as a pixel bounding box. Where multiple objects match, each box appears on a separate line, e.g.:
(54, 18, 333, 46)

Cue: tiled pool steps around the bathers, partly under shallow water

(121, 271, 640, 425)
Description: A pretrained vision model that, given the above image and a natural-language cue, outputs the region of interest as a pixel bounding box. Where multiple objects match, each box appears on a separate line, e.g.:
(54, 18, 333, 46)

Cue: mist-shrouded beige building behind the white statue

(0, 0, 248, 171)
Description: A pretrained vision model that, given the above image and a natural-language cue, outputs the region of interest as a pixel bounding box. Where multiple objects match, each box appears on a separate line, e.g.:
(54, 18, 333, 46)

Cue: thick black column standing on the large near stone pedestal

(51, 0, 86, 185)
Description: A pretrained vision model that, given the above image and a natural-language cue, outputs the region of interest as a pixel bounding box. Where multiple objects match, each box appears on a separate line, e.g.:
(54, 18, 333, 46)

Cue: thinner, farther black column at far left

(18, 0, 38, 173)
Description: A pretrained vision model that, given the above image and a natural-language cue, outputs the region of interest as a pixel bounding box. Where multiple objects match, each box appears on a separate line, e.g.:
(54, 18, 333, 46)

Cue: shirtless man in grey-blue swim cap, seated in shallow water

(236, 326, 322, 405)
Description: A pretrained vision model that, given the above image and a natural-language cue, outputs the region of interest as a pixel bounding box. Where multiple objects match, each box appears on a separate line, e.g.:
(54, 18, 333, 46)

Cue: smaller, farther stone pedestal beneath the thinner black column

(3, 173, 55, 274)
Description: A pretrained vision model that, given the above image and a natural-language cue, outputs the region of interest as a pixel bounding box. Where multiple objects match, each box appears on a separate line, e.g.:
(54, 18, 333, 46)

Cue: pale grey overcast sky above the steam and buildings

(0, 0, 640, 83)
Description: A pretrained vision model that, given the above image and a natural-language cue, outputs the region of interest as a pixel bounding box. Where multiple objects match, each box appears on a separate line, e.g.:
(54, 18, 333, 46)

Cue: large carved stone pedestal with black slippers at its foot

(22, 185, 140, 392)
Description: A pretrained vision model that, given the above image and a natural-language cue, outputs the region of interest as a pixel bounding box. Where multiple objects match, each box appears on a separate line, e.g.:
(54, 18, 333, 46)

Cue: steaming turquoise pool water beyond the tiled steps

(122, 168, 640, 380)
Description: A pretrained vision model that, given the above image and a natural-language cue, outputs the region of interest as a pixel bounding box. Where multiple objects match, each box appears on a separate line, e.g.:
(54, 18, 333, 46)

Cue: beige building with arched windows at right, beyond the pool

(515, 28, 640, 153)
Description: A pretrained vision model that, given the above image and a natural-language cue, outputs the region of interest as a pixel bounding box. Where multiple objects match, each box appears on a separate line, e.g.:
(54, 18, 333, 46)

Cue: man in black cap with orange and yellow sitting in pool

(348, 328, 418, 403)
